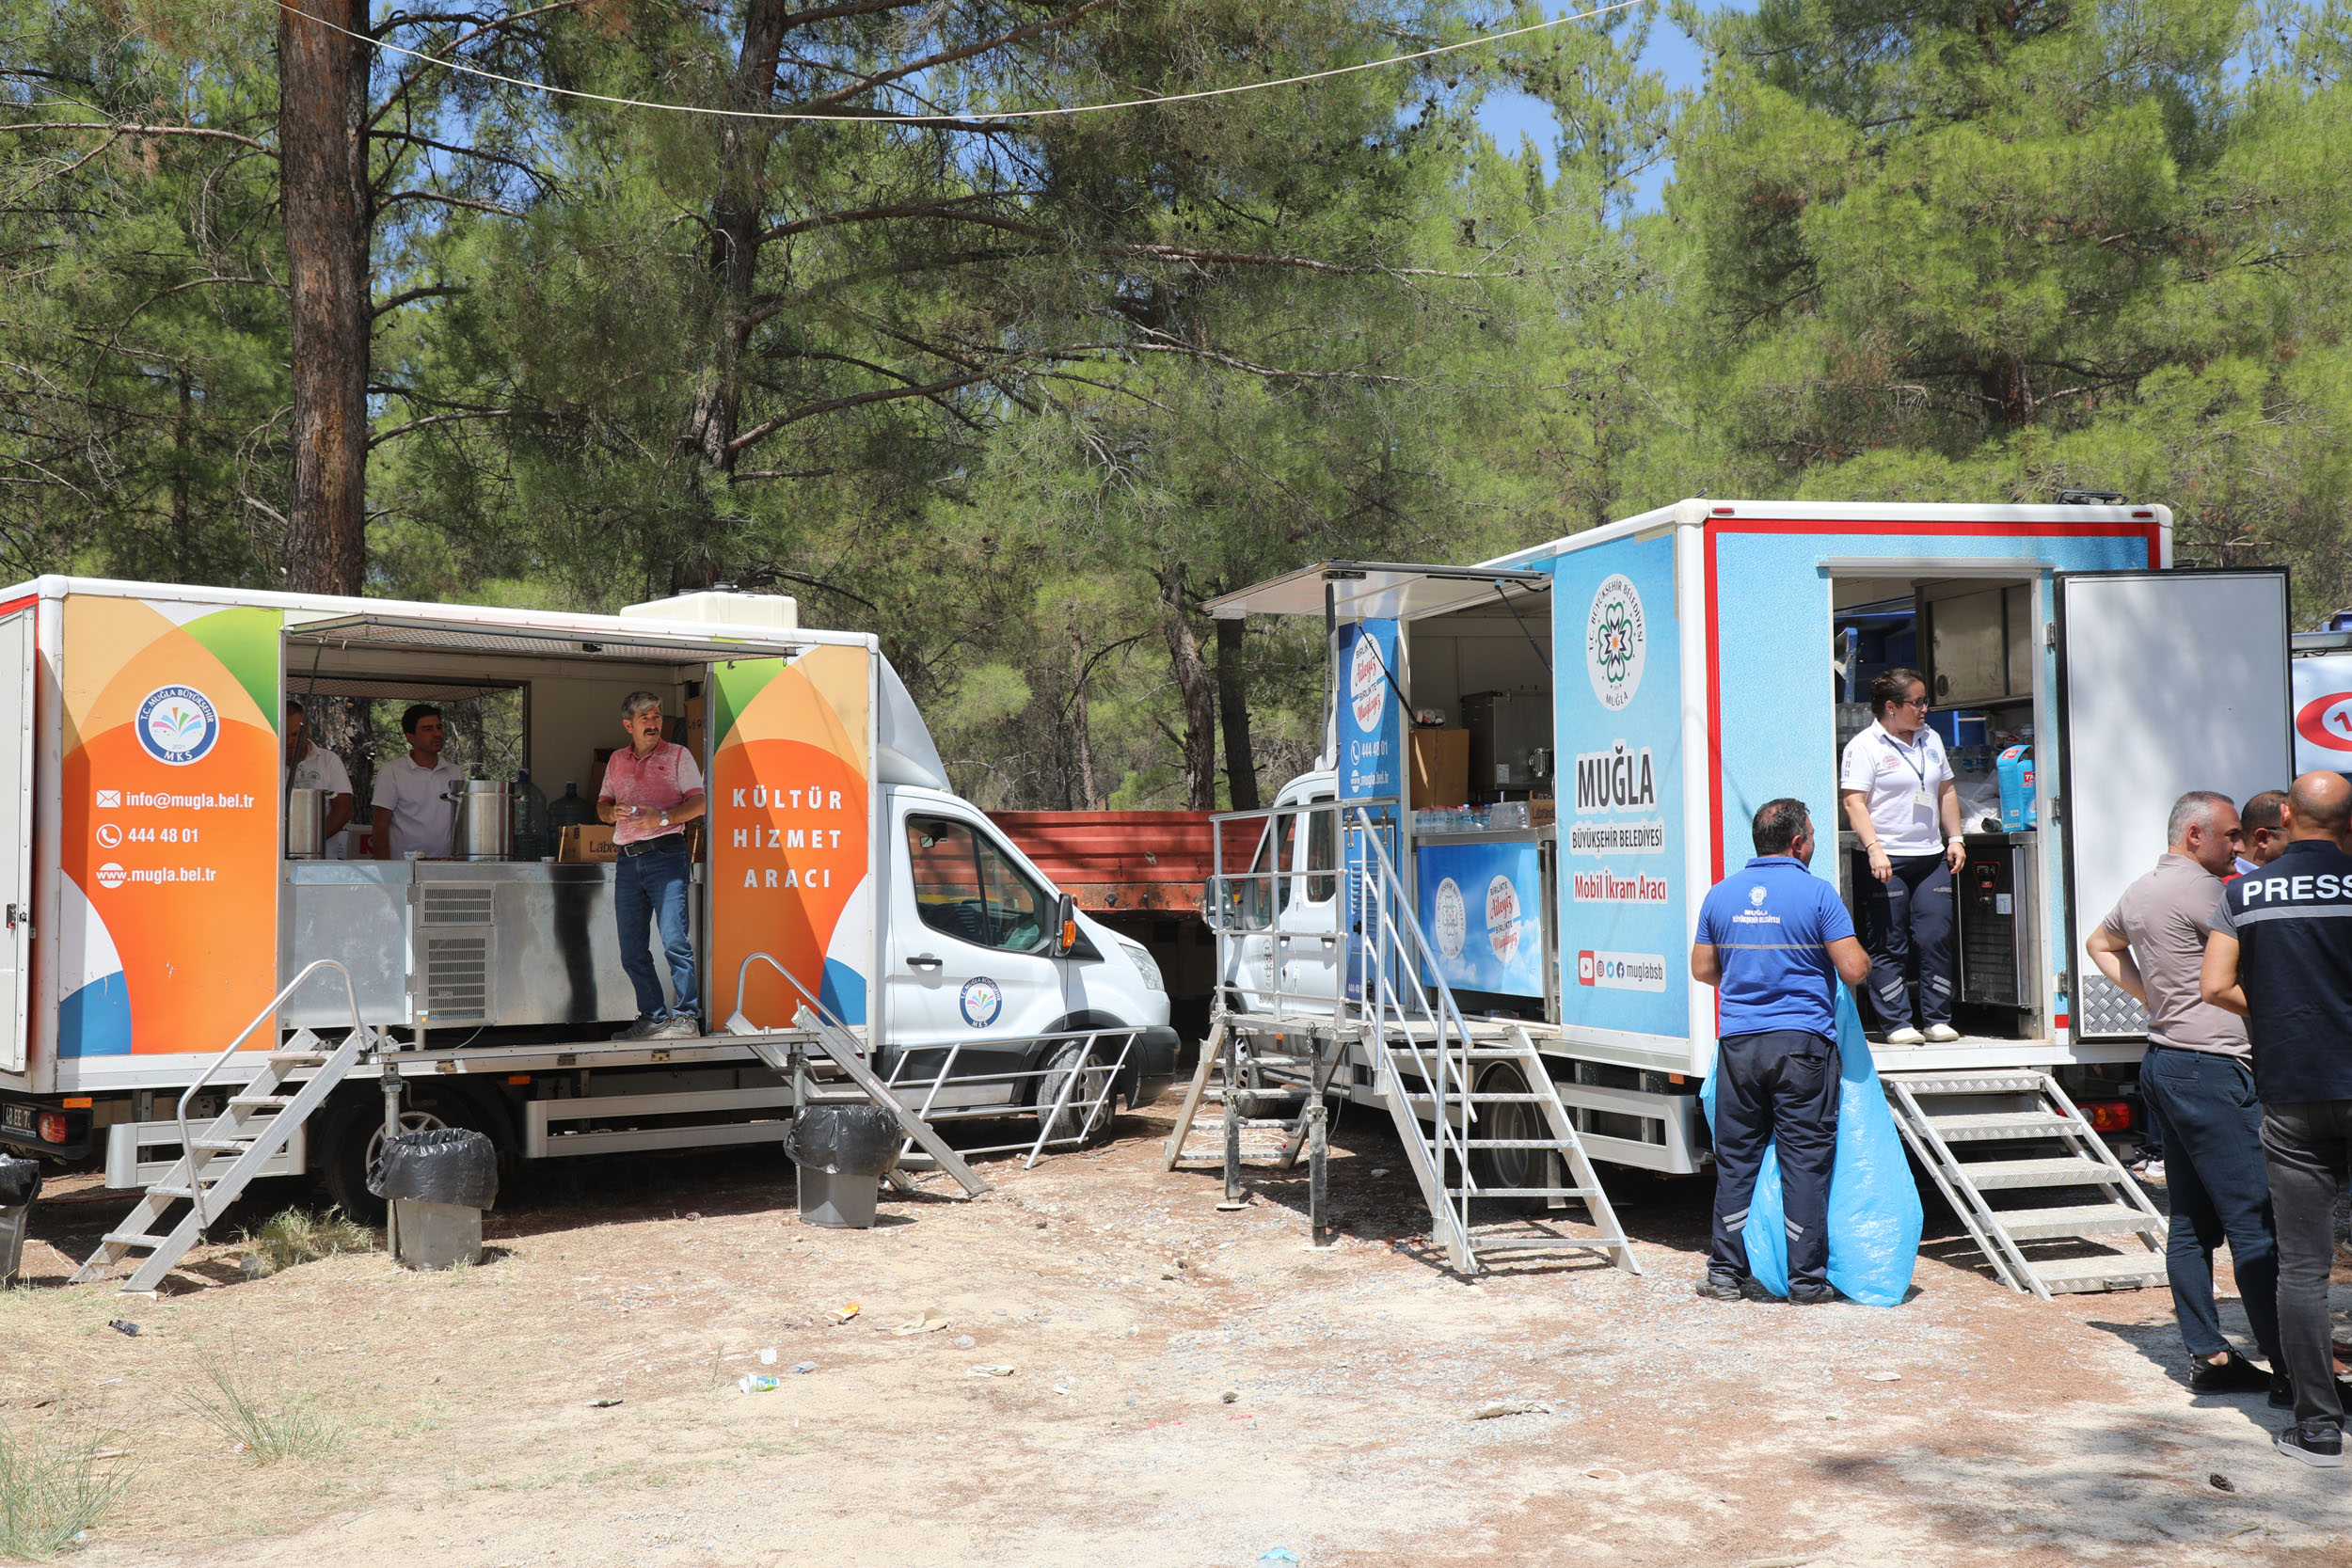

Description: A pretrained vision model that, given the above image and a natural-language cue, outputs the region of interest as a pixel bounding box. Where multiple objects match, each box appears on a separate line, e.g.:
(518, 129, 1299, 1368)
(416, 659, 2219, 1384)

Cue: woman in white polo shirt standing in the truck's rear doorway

(1837, 670, 1969, 1046)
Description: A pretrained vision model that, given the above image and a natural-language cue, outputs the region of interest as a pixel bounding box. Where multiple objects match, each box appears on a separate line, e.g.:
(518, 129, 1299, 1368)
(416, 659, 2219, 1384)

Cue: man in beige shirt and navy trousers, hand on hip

(2084, 790, 2281, 1394)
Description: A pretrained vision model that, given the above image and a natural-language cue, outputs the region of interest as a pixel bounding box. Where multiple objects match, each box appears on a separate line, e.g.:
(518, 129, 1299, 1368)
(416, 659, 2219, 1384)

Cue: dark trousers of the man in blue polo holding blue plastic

(1708, 1030, 1839, 1295)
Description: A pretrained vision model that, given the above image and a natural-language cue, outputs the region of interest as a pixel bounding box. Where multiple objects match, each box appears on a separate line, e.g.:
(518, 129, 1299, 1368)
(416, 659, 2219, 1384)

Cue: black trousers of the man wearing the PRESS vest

(2258, 1104, 2352, 1427)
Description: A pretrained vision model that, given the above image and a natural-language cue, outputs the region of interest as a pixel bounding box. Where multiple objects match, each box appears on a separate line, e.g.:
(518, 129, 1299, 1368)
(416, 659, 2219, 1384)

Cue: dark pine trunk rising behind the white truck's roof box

(677, 0, 795, 588)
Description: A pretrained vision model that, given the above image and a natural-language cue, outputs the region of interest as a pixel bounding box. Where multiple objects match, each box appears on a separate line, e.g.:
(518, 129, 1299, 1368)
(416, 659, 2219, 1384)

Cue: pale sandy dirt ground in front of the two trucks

(0, 1101, 2352, 1568)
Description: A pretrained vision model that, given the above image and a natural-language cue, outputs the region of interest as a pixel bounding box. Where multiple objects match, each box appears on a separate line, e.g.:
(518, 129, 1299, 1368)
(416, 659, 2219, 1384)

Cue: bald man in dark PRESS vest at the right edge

(2200, 773, 2352, 1467)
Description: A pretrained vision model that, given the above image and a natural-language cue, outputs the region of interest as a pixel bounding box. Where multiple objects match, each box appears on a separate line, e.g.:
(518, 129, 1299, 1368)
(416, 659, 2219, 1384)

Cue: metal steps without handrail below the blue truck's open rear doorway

(1880, 1069, 2169, 1300)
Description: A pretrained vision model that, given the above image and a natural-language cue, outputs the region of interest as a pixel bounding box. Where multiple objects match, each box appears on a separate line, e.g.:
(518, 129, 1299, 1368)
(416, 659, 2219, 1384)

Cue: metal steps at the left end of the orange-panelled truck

(71, 1029, 379, 1291)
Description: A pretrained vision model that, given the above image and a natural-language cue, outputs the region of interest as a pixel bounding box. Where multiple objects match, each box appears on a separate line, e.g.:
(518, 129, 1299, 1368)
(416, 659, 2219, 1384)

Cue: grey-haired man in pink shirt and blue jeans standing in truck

(596, 691, 710, 1039)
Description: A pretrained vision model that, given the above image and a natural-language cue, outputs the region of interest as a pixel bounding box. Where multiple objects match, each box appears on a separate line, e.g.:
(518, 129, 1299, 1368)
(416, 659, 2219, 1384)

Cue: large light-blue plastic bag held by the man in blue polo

(1698, 985, 1924, 1307)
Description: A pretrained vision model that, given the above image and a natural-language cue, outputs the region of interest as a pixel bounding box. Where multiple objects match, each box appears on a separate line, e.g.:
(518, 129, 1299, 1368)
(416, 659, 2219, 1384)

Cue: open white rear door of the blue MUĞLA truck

(2042, 566, 2296, 1041)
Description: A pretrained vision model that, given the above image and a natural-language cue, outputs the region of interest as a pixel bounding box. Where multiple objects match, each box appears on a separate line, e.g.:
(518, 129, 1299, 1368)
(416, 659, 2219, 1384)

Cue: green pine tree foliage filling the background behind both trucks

(0, 0, 2352, 789)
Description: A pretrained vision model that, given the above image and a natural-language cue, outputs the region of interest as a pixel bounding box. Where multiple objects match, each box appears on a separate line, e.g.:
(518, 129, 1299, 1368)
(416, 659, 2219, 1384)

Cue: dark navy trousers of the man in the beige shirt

(2140, 1046, 2281, 1370)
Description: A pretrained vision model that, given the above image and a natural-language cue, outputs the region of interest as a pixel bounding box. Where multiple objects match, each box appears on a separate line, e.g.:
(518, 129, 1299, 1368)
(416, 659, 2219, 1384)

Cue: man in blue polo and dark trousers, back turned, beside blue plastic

(1692, 800, 1870, 1305)
